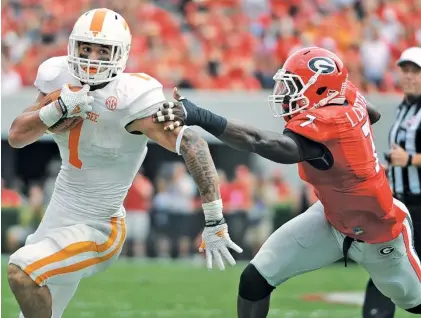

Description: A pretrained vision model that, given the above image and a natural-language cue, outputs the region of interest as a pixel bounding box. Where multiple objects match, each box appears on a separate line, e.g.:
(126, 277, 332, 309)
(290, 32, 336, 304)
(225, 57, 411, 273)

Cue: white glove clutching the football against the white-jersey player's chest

(39, 84, 94, 127)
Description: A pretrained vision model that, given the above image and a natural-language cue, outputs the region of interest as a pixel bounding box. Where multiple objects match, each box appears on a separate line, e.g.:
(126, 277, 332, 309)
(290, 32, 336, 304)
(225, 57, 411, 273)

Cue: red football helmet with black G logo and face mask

(268, 47, 348, 118)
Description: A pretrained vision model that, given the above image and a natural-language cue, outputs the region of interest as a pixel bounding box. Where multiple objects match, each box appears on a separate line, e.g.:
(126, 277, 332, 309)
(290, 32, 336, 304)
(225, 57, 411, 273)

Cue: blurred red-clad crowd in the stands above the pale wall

(1, 0, 421, 94)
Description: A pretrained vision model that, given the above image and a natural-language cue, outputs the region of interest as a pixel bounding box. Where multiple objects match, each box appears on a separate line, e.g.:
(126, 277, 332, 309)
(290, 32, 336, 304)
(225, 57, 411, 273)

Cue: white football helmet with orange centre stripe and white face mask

(67, 8, 132, 85)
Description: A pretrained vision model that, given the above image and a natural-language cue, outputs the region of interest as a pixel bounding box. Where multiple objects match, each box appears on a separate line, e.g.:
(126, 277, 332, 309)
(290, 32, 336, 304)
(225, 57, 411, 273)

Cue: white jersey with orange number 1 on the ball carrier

(35, 56, 165, 219)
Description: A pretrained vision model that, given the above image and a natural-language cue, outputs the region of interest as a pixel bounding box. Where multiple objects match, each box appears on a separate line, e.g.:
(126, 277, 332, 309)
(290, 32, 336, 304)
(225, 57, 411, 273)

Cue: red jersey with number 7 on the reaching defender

(286, 84, 406, 243)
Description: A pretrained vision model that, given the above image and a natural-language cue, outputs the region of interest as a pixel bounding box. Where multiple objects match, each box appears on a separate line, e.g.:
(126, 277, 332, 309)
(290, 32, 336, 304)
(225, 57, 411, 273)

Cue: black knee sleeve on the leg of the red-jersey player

(238, 264, 275, 301)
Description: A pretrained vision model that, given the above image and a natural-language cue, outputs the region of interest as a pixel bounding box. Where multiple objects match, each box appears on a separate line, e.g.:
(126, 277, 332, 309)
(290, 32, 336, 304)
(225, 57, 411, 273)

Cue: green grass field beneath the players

(1, 258, 413, 318)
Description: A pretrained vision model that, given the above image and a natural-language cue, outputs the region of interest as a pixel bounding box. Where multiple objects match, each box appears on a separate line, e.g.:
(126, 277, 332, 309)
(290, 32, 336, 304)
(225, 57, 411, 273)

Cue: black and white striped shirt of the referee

(388, 99, 421, 196)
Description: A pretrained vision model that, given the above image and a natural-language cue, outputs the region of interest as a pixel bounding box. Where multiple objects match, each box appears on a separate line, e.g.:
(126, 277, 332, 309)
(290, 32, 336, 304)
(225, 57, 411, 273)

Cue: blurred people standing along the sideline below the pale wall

(1, 160, 315, 259)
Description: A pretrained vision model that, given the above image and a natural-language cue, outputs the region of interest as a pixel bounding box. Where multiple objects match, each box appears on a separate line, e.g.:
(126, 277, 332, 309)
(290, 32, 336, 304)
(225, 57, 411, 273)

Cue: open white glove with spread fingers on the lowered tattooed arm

(199, 219, 243, 270)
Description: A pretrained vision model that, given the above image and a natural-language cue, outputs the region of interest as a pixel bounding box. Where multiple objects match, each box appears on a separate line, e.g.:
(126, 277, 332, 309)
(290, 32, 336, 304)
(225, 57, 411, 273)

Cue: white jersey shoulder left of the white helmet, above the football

(34, 56, 80, 94)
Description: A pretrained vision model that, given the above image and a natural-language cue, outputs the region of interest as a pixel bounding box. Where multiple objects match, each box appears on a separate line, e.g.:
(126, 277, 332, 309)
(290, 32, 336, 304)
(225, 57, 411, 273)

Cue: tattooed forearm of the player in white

(180, 129, 221, 203)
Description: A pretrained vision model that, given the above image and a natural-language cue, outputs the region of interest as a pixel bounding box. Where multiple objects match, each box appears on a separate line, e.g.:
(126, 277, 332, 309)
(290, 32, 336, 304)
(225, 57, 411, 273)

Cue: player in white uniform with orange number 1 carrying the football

(8, 9, 241, 318)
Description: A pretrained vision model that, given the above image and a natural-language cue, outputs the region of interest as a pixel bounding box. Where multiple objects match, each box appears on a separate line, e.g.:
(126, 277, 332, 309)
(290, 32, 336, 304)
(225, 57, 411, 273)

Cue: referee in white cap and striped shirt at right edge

(363, 47, 421, 318)
